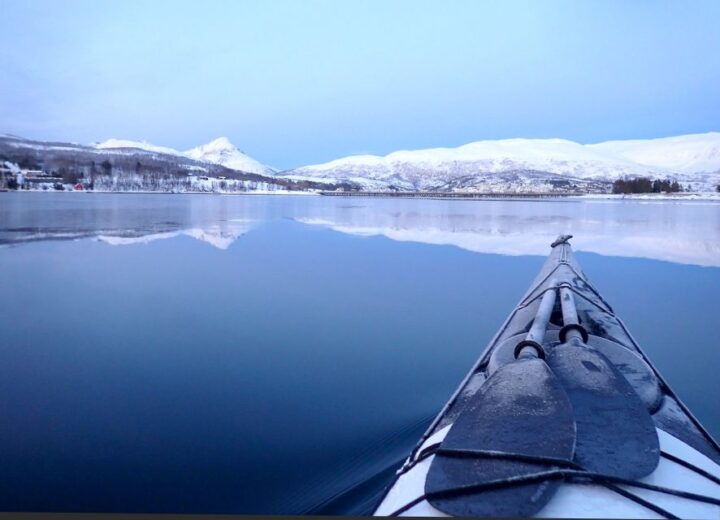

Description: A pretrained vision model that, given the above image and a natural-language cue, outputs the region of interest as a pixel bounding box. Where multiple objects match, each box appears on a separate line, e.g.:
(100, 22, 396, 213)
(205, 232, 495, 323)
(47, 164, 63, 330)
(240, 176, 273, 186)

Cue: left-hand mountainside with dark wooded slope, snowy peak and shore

(0, 135, 338, 193)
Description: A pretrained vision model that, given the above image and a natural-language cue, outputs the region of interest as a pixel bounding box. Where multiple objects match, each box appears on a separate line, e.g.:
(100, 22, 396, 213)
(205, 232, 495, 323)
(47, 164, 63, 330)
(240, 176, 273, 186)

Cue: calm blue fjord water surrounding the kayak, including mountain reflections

(0, 193, 720, 514)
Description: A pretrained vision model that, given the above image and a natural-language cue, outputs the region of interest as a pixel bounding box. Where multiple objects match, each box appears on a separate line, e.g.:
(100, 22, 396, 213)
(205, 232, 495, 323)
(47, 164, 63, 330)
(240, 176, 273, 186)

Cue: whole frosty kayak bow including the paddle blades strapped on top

(375, 235, 720, 518)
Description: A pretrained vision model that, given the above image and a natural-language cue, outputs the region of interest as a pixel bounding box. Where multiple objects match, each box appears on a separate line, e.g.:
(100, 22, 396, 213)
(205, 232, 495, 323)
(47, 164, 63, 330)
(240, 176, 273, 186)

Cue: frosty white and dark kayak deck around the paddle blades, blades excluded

(375, 237, 720, 518)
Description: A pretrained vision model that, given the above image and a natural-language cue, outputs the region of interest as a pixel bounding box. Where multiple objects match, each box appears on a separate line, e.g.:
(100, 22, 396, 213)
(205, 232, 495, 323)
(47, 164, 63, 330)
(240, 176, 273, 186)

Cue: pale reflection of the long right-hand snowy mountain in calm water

(298, 207, 720, 266)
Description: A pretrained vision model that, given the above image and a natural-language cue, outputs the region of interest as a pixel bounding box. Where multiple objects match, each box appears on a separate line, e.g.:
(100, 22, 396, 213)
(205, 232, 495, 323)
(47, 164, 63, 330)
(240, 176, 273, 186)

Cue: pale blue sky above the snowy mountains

(0, 0, 720, 168)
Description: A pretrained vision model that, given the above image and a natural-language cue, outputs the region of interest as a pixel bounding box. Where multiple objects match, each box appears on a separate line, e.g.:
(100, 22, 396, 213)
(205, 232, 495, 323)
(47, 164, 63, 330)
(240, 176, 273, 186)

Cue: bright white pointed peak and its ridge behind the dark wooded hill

(94, 137, 275, 175)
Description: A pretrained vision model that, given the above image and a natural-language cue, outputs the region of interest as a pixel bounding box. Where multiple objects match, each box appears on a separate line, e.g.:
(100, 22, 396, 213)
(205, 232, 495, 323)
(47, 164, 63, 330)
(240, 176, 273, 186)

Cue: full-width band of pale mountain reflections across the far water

(0, 194, 720, 266)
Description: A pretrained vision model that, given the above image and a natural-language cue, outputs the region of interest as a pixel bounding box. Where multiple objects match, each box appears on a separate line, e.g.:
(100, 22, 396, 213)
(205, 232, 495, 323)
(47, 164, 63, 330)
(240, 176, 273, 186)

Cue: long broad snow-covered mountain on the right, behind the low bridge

(282, 132, 720, 191)
